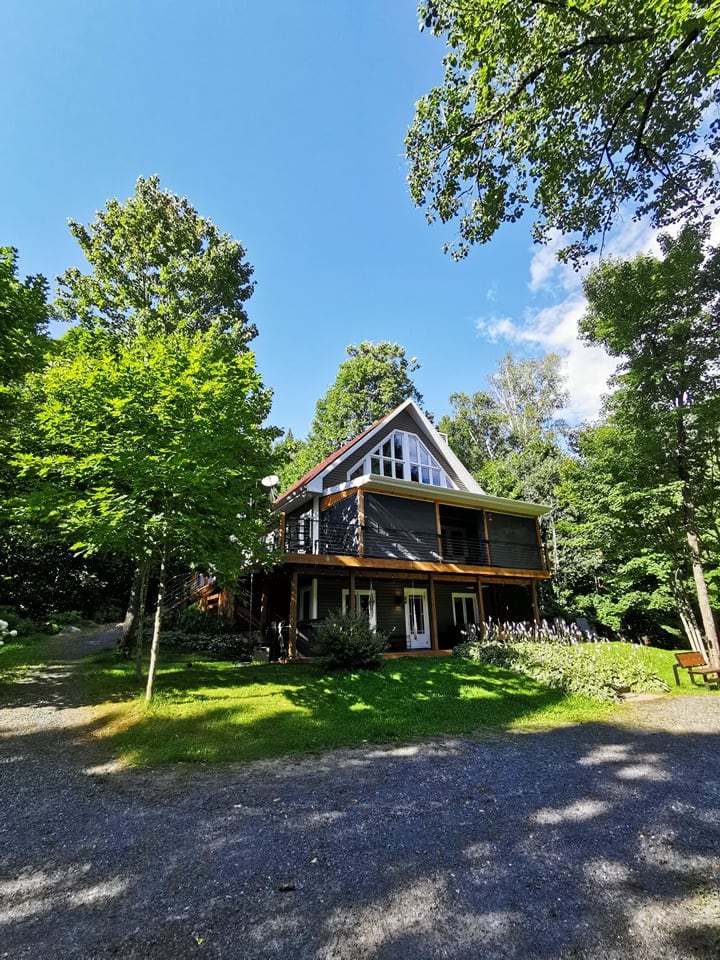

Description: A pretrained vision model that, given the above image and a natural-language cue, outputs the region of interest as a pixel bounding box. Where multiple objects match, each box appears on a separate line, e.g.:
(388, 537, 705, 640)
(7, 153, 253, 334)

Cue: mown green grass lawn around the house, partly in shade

(0, 638, 702, 766)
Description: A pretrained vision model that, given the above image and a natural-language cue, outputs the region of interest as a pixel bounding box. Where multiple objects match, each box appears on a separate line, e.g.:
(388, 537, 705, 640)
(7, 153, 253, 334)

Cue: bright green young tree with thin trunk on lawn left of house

(20, 323, 277, 698)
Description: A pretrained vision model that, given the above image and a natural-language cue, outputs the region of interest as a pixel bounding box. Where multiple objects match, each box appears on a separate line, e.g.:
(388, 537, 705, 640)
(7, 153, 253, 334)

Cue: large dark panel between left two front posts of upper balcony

(365, 493, 439, 561)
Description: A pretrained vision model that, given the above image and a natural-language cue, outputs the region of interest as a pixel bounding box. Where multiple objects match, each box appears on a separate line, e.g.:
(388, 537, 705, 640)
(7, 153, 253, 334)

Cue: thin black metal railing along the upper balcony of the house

(284, 517, 548, 570)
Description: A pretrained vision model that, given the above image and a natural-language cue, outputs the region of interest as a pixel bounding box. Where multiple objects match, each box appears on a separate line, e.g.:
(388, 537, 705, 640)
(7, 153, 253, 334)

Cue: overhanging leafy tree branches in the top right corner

(406, 0, 720, 262)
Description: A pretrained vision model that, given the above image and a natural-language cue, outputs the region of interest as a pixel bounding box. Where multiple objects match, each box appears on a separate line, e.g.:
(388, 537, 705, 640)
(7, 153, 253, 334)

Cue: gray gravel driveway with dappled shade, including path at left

(0, 631, 720, 960)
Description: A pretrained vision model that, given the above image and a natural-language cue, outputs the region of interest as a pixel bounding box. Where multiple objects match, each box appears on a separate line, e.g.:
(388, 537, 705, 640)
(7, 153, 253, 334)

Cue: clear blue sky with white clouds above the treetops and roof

(0, 0, 648, 436)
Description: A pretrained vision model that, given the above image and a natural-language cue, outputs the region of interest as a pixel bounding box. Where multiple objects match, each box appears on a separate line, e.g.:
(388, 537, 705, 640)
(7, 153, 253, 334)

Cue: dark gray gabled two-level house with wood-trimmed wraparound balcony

(261, 400, 550, 657)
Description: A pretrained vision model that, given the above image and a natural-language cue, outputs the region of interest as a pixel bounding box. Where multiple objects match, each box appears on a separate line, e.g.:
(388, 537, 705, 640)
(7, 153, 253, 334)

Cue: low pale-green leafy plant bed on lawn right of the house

(453, 642, 668, 701)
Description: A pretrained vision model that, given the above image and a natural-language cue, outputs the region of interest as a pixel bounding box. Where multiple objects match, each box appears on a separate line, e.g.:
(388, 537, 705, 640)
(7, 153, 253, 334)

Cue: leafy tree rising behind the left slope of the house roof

(284, 340, 422, 482)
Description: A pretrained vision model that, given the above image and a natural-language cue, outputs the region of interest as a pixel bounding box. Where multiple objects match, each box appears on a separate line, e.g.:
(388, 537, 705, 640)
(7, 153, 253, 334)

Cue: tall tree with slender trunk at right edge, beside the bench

(580, 227, 720, 665)
